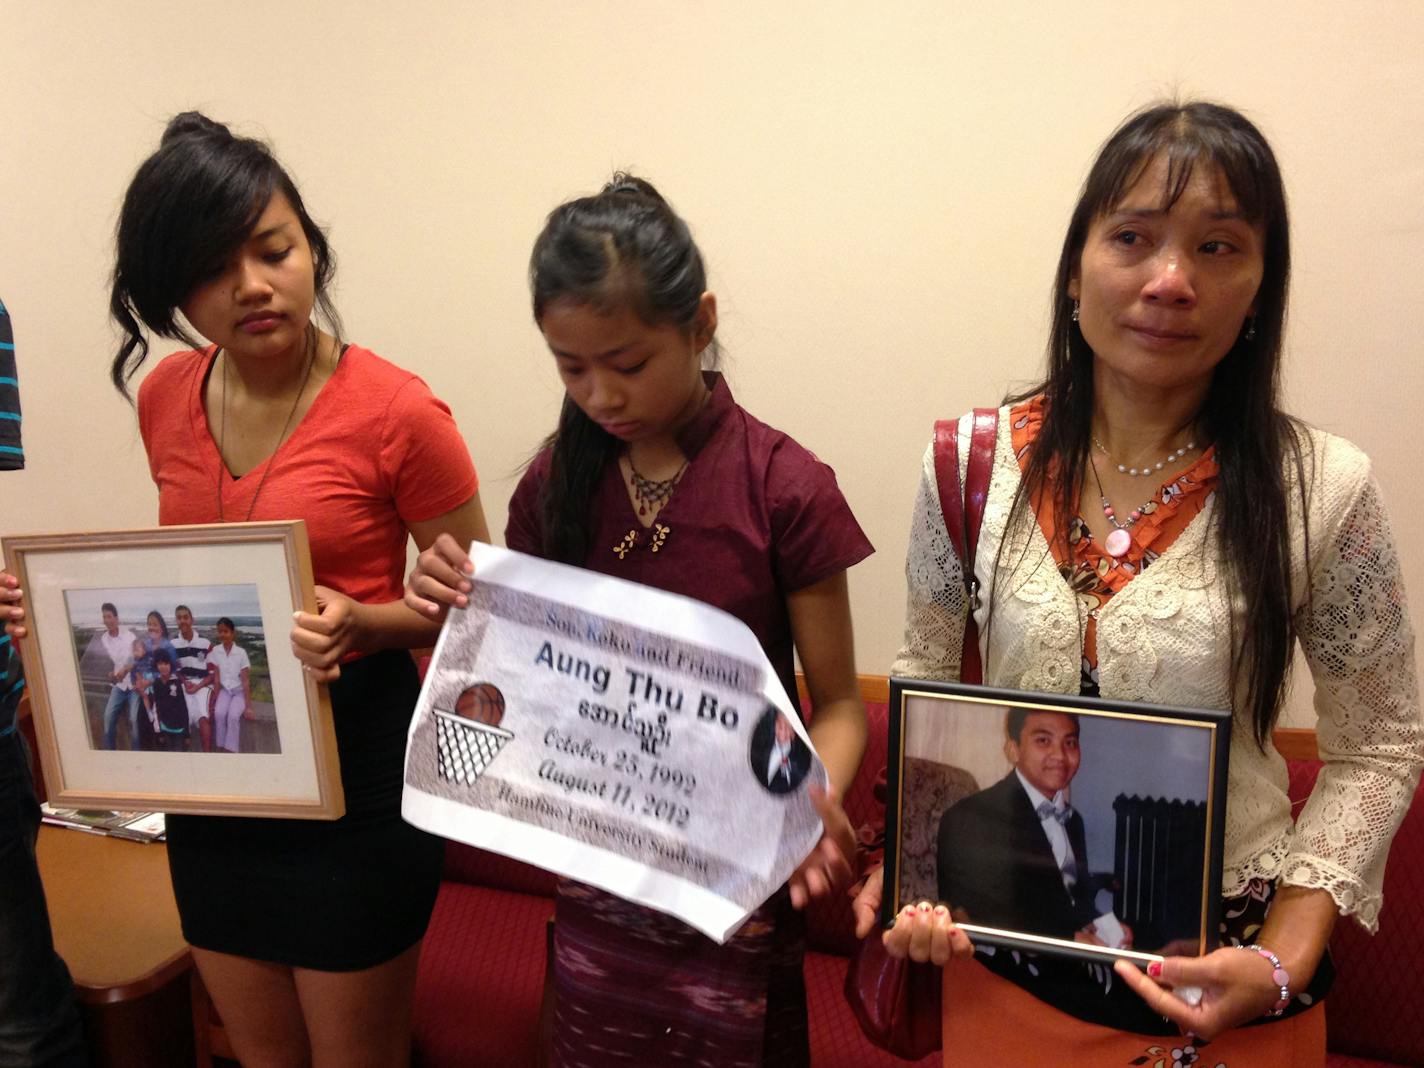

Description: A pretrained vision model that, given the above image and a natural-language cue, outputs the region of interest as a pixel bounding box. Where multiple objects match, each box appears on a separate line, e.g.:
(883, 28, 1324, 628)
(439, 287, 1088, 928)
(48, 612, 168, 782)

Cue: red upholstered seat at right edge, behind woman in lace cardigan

(1287, 755, 1424, 1068)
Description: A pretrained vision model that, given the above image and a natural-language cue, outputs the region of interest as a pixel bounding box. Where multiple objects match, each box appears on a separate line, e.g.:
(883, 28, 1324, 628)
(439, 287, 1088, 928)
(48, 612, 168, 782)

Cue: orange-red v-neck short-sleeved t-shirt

(138, 345, 480, 604)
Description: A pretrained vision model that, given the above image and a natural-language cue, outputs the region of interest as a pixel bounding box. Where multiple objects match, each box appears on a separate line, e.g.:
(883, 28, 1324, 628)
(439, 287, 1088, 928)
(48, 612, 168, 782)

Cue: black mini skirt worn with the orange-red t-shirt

(168, 649, 444, 971)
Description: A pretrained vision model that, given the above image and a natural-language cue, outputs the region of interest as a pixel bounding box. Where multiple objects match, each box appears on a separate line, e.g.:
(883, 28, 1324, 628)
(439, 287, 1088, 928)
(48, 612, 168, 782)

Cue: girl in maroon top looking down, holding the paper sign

(406, 175, 871, 1067)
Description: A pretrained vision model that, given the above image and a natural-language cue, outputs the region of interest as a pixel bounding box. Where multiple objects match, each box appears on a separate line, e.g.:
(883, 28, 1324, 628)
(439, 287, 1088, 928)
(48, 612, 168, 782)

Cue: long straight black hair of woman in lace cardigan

(995, 101, 1310, 746)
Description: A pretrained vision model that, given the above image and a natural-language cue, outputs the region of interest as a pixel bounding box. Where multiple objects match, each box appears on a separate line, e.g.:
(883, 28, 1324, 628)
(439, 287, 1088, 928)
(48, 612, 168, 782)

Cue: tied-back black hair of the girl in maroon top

(530, 172, 716, 564)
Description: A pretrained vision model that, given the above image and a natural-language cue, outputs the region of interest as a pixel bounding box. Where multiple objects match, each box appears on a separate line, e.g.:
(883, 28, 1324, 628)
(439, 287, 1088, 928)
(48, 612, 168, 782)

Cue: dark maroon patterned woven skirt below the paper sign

(553, 879, 810, 1068)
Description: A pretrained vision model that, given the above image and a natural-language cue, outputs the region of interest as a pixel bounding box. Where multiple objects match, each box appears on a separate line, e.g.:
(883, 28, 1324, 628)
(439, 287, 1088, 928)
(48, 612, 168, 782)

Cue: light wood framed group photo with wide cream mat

(0, 521, 345, 819)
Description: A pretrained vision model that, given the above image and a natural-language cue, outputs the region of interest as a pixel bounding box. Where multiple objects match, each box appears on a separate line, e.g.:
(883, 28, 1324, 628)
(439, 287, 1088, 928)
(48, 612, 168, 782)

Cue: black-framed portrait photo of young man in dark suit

(881, 678, 1230, 963)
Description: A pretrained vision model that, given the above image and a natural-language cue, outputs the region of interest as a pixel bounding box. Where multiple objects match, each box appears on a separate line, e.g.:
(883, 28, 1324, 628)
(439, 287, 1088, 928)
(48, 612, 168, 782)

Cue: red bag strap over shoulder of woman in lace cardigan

(934, 407, 998, 682)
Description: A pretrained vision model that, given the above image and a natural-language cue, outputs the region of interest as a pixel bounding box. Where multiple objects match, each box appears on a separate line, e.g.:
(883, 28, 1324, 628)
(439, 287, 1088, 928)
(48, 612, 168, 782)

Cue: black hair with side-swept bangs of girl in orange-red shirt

(108, 111, 342, 397)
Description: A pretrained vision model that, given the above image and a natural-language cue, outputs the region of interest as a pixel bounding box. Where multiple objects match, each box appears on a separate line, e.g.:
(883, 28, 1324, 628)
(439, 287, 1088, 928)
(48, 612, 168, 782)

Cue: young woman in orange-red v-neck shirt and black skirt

(9, 112, 488, 1068)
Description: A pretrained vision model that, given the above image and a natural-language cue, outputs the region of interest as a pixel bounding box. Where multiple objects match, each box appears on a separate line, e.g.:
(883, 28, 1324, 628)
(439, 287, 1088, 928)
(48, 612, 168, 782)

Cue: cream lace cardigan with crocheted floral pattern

(893, 409, 1424, 931)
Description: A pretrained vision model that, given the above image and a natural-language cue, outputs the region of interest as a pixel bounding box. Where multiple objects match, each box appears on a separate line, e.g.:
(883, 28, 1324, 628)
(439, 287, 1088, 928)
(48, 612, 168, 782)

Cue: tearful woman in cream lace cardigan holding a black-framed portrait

(857, 103, 1424, 1067)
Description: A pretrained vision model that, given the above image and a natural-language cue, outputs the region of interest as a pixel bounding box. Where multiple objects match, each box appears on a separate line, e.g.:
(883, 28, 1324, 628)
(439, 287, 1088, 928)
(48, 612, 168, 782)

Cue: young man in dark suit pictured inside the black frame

(937, 708, 1132, 948)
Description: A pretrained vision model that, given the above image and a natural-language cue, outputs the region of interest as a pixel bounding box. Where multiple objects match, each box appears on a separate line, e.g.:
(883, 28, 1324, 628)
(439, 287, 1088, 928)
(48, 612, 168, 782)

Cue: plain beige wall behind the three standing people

(0, 0, 1424, 729)
